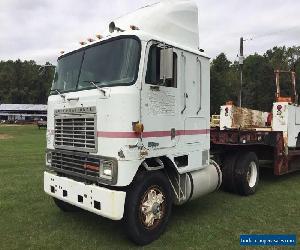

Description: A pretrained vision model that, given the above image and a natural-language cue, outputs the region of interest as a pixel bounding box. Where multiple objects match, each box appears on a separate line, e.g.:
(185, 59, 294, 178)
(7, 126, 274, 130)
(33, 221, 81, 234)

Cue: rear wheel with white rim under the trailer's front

(234, 152, 259, 195)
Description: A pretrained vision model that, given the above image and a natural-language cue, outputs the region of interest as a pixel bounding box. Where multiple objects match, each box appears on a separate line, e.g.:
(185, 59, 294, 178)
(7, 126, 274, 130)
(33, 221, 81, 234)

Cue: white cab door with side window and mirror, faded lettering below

(141, 42, 178, 149)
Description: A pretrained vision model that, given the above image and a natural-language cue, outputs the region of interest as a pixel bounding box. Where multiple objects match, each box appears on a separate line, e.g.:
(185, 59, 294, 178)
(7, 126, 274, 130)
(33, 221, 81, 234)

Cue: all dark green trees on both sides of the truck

(0, 46, 300, 114)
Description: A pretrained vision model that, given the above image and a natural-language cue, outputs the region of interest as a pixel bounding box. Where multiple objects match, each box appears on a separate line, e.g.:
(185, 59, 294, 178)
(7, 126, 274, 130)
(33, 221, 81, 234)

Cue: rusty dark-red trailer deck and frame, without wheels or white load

(210, 128, 300, 175)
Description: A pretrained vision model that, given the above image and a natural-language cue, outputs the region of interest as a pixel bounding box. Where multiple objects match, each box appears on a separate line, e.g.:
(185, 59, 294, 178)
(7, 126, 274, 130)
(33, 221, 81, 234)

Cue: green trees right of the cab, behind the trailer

(210, 46, 300, 114)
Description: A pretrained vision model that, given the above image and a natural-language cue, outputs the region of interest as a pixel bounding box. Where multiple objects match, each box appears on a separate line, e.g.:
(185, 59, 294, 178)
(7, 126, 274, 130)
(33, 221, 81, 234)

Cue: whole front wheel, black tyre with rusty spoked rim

(124, 171, 172, 245)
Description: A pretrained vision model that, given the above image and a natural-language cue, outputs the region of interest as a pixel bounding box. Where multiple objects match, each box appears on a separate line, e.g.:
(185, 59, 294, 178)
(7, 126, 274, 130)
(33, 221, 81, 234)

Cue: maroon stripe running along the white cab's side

(97, 129, 210, 138)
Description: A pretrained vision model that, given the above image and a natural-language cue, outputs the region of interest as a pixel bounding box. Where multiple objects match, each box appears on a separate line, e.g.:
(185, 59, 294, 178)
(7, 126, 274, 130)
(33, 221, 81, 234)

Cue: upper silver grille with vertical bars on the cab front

(54, 114, 97, 152)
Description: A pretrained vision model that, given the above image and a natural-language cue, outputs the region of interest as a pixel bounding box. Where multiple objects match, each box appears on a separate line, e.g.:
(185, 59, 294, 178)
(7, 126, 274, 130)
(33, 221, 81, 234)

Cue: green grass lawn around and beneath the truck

(0, 126, 300, 249)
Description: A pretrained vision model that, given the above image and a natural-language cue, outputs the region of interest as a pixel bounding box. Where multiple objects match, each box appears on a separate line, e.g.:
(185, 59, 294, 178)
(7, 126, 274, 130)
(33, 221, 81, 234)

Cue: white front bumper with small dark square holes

(44, 172, 126, 220)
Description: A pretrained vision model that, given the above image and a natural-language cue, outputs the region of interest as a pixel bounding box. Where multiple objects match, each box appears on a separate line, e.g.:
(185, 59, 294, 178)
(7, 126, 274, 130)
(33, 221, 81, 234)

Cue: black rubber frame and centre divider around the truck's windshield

(50, 35, 142, 95)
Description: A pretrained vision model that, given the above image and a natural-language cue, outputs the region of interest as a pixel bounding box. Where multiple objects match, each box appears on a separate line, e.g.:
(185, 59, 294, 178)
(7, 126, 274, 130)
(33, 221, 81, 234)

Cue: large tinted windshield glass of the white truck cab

(51, 37, 140, 94)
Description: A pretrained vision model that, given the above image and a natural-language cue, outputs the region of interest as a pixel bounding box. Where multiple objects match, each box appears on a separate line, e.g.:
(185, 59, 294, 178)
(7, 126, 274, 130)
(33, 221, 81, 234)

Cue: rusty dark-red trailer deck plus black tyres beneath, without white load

(210, 127, 300, 195)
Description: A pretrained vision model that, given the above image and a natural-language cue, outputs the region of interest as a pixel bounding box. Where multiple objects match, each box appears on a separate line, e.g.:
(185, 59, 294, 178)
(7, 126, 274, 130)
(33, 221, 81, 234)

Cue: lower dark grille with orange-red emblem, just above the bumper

(51, 151, 100, 180)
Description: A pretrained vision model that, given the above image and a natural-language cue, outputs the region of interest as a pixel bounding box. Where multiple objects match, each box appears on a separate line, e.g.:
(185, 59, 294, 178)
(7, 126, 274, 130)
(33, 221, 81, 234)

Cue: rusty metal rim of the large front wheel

(139, 186, 166, 230)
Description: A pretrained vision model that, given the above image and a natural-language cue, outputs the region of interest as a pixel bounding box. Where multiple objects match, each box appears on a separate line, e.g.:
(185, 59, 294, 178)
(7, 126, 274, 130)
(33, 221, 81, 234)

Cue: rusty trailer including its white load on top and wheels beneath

(210, 70, 300, 195)
